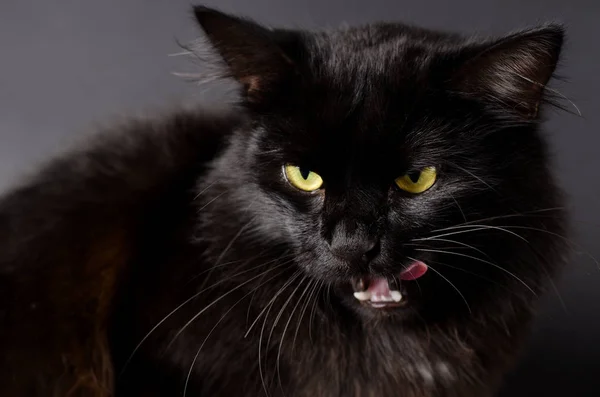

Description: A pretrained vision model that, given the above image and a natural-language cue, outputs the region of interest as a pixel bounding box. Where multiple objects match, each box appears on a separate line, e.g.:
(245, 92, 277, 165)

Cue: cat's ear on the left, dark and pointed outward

(194, 6, 293, 101)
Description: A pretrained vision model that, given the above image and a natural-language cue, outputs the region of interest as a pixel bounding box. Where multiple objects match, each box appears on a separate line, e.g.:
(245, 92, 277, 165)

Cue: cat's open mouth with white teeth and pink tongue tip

(352, 261, 427, 309)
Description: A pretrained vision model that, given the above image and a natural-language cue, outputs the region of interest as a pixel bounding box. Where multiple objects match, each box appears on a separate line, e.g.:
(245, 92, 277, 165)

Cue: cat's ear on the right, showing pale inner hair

(452, 24, 564, 119)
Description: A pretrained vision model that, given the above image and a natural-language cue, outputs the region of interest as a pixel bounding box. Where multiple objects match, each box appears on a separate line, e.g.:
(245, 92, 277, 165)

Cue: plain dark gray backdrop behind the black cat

(0, 0, 600, 397)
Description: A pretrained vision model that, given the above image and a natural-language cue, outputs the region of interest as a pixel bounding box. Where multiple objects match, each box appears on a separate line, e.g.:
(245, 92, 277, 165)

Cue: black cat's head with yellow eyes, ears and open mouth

(195, 7, 563, 320)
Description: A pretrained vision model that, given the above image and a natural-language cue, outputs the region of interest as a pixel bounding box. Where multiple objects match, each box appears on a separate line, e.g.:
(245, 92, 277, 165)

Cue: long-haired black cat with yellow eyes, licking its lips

(0, 7, 567, 397)
